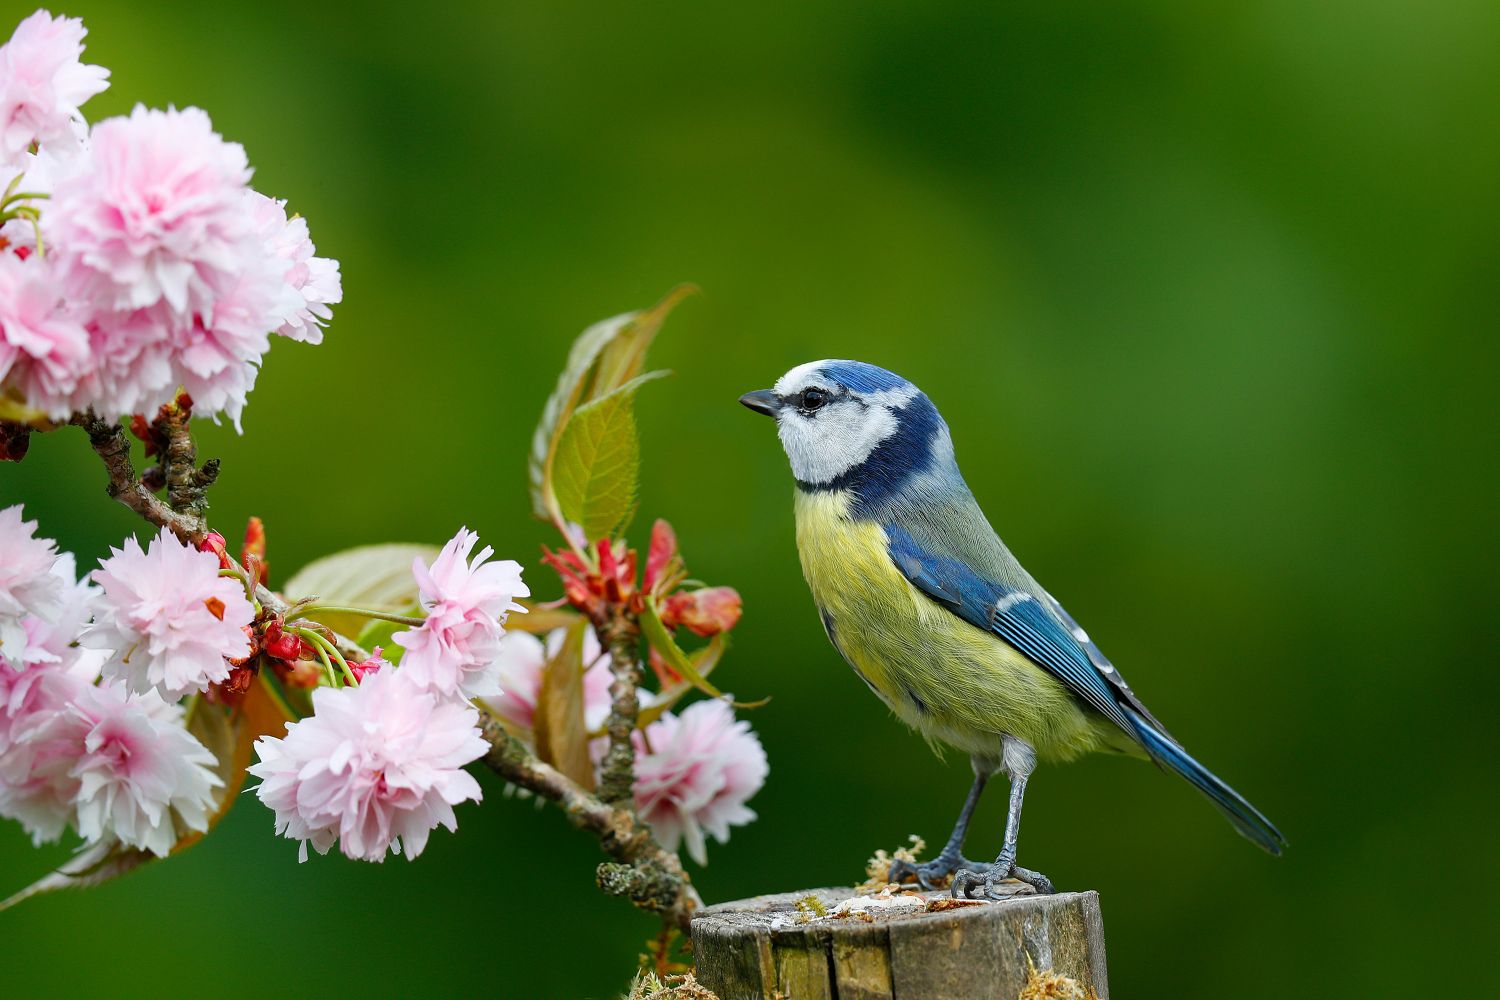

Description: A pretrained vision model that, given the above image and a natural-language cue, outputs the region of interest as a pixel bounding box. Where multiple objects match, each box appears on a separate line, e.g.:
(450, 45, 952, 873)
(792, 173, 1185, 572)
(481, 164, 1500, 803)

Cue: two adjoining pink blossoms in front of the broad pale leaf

(251, 528, 528, 861)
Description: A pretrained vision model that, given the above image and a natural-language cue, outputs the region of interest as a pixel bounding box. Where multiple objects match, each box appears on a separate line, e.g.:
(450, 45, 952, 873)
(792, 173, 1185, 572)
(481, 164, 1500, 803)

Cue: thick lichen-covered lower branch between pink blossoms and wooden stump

(480, 704, 702, 933)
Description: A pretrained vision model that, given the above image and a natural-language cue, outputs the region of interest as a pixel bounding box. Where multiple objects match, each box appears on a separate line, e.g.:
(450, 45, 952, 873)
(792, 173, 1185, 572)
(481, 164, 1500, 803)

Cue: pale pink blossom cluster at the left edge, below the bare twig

(0, 507, 222, 856)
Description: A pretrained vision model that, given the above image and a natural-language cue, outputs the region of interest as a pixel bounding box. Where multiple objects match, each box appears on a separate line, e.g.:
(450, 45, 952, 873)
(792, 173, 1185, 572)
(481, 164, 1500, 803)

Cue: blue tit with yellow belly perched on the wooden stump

(740, 360, 1287, 900)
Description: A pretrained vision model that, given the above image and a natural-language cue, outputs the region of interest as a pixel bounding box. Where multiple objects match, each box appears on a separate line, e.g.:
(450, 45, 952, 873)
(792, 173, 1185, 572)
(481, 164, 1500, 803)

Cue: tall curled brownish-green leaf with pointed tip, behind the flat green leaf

(528, 285, 696, 522)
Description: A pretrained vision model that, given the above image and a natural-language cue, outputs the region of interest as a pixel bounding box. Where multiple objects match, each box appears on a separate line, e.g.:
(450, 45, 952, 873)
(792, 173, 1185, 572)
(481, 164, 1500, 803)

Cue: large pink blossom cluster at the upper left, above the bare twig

(0, 10, 342, 426)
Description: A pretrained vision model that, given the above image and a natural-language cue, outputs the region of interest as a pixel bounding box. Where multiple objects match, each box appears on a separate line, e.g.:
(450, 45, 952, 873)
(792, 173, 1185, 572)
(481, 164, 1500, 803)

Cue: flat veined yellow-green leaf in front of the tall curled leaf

(552, 372, 666, 541)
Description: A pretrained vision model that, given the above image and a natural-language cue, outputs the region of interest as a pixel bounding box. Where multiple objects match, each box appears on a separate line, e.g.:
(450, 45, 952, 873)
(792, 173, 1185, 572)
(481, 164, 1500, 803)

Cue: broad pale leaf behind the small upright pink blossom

(282, 543, 438, 645)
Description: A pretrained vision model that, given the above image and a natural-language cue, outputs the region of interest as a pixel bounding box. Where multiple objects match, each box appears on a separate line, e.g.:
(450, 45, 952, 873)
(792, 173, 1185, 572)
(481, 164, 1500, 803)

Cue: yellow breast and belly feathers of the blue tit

(797, 490, 1113, 759)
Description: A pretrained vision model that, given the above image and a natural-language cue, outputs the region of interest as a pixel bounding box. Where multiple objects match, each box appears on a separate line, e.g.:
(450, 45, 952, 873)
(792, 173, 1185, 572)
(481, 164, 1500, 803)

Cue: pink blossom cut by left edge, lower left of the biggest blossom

(0, 253, 93, 420)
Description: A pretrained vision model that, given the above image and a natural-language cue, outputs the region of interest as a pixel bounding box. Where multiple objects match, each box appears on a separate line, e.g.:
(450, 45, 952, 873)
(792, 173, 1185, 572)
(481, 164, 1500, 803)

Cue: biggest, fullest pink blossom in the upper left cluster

(45, 106, 295, 427)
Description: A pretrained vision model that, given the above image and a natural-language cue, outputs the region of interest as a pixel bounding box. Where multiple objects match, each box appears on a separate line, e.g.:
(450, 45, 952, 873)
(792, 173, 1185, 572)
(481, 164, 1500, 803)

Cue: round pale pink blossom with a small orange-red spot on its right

(81, 528, 255, 700)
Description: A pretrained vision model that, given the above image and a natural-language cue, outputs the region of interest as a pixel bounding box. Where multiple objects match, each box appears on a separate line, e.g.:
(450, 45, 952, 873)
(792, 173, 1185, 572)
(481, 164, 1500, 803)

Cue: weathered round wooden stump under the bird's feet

(693, 883, 1110, 1000)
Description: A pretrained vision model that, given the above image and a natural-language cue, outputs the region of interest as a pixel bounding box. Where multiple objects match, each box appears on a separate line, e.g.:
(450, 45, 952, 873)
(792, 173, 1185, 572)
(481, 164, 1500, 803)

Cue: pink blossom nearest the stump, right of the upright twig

(635, 700, 770, 865)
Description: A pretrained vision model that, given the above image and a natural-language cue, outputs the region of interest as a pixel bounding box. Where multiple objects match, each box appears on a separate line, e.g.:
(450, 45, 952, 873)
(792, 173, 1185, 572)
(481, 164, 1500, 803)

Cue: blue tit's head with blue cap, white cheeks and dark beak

(740, 361, 953, 487)
